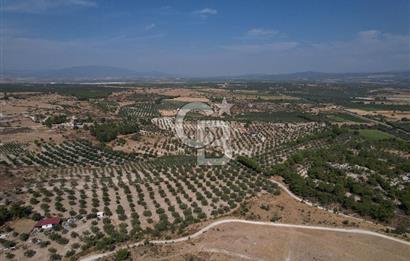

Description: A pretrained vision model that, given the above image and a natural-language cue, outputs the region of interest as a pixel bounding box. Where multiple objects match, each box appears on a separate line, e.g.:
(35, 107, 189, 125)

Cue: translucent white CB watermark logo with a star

(175, 98, 233, 165)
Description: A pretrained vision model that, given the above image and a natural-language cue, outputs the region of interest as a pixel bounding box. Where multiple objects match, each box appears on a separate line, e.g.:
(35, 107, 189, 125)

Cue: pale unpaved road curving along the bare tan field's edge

(80, 219, 410, 261)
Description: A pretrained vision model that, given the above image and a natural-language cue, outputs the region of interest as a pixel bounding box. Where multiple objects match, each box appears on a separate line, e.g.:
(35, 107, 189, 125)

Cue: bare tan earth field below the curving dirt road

(132, 221, 410, 261)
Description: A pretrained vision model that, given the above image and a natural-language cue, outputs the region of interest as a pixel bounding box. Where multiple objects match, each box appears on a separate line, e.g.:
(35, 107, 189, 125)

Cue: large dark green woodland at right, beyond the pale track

(270, 135, 410, 221)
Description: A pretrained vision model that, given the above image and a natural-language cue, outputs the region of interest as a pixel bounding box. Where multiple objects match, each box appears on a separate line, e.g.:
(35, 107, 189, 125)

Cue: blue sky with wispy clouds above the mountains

(0, 0, 410, 76)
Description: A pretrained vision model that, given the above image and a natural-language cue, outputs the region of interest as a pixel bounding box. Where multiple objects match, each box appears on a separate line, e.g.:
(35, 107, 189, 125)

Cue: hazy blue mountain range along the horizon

(5, 65, 410, 82)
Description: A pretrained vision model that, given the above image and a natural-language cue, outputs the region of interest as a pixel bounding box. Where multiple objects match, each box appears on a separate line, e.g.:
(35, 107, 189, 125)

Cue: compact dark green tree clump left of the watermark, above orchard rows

(90, 121, 139, 142)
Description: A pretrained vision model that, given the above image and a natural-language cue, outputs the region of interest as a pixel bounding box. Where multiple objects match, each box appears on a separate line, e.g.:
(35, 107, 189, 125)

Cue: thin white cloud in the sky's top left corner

(1, 0, 97, 13)
